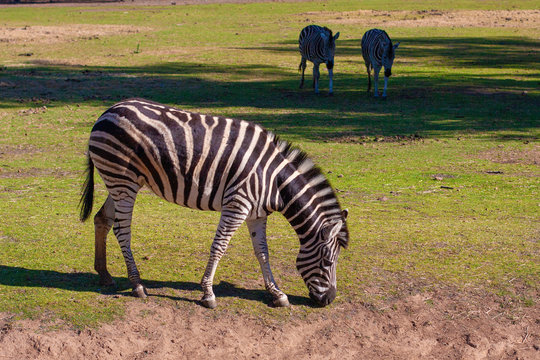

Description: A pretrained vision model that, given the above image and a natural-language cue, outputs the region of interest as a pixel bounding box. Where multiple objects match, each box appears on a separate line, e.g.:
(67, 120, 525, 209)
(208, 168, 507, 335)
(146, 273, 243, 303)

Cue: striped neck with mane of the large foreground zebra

(277, 142, 348, 247)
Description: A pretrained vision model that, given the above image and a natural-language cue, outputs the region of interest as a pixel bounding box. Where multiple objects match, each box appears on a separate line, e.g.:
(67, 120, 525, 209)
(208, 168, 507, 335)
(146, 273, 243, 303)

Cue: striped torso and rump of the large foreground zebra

(89, 99, 277, 217)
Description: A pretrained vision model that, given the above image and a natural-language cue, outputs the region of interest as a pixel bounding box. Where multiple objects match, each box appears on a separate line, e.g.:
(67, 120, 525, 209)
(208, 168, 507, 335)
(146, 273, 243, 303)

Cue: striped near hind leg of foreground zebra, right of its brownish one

(113, 195, 147, 298)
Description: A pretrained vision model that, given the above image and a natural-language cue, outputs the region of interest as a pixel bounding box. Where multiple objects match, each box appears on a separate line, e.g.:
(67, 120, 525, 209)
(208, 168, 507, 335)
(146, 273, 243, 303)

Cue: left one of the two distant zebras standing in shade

(298, 25, 339, 95)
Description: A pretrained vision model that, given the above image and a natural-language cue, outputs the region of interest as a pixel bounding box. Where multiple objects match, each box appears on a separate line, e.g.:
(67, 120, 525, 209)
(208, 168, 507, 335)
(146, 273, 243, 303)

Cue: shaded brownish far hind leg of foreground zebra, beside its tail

(94, 196, 114, 286)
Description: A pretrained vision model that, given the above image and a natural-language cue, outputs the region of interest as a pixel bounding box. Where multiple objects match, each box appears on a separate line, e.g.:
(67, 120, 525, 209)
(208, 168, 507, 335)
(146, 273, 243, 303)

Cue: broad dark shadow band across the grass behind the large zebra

(0, 38, 540, 141)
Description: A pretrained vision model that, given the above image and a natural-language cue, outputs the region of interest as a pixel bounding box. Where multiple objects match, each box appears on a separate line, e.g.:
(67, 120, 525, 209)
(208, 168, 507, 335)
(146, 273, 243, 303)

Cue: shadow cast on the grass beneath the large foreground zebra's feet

(0, 265, 315, 307)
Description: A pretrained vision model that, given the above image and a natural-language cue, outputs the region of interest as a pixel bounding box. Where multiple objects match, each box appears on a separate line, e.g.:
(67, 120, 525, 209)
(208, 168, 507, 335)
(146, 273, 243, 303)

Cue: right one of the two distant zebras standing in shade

(362, 29, 399, 97)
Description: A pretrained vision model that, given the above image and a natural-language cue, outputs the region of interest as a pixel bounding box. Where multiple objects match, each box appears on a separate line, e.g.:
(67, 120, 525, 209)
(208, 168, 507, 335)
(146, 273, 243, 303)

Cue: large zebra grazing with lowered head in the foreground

(80, 99, 349, 308)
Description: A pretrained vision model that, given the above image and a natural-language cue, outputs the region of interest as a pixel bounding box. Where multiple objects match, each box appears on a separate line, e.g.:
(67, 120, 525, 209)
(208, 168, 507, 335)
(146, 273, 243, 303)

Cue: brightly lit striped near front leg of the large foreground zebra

(201, 208, 247, 309)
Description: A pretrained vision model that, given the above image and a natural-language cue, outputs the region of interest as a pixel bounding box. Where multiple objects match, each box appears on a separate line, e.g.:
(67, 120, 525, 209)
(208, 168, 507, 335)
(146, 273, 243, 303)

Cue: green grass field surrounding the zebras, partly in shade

(0, 1, 540, 326)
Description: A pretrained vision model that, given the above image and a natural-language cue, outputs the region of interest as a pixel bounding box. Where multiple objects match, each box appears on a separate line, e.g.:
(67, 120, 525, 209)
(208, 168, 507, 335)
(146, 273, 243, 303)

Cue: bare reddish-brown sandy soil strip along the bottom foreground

(0, 290, 540, 360)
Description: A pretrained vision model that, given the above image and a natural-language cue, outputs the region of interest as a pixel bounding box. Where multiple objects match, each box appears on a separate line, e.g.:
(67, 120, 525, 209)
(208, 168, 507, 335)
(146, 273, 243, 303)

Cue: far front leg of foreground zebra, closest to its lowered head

(246, 218, 289, 307)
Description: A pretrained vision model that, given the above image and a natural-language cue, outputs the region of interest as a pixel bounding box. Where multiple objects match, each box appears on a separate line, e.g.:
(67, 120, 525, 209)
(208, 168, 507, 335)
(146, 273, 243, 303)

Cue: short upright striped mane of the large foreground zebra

(274, 135, 349, 248)
